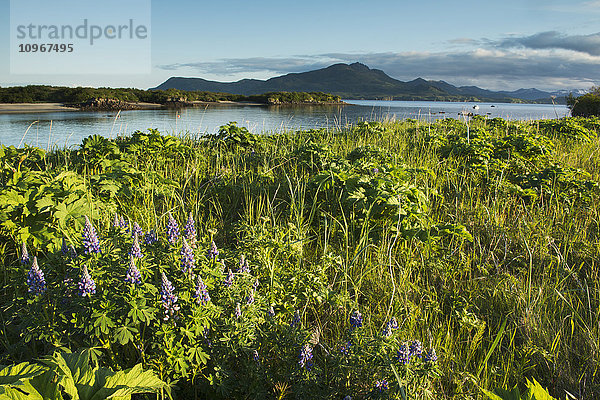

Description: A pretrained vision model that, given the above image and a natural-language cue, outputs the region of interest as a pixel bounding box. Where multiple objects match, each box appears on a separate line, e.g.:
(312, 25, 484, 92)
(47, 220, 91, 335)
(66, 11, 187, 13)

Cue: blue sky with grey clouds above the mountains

(0, 0, 600, 90)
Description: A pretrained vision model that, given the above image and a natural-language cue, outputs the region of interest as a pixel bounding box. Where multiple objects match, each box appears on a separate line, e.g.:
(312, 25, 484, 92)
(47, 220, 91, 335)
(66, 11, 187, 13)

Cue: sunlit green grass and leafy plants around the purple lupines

(0, 118, 600, 399)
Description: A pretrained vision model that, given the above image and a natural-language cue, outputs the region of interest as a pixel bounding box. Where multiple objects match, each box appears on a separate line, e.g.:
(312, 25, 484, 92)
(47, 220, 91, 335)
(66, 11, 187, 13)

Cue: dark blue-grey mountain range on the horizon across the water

(151, 62, 579, 103)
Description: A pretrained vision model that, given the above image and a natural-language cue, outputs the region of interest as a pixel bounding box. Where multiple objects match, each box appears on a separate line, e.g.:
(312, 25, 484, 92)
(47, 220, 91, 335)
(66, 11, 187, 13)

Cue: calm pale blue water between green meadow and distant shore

(0, 100, 569, 148)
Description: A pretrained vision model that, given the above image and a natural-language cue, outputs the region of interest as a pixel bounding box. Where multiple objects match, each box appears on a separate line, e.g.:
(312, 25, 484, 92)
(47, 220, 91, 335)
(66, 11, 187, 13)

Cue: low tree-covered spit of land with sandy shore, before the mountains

(0, 85, 346, 113)
